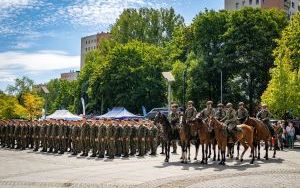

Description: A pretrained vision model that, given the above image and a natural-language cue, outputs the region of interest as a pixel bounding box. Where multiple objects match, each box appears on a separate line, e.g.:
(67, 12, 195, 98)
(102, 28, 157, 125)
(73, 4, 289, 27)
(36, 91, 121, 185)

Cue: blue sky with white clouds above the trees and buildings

(0, 0, 224, 90)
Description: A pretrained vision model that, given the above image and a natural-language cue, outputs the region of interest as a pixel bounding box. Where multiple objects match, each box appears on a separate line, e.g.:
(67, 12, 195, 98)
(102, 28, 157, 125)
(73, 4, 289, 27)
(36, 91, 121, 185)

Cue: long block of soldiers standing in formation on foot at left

(0, 120, 160, 159)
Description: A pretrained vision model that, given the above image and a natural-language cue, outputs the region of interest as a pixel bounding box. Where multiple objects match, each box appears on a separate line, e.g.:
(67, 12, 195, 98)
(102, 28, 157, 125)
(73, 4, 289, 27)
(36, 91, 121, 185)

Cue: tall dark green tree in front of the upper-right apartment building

(223, 8, 287, 112)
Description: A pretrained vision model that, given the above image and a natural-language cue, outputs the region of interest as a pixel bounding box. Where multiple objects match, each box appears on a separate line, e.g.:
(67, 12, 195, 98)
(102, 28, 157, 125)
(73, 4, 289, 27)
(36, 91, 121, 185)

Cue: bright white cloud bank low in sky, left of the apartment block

(0, 51, 80, 82)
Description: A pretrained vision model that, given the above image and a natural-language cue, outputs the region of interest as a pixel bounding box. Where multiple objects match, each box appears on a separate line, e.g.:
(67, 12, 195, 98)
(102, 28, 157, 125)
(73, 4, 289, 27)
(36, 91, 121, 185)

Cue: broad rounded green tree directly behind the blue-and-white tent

(89, 41, 166, 113)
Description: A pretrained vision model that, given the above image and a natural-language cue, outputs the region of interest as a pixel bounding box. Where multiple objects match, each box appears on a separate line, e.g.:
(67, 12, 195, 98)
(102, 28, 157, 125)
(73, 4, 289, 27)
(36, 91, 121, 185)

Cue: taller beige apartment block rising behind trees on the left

(80, 32, 110, 69)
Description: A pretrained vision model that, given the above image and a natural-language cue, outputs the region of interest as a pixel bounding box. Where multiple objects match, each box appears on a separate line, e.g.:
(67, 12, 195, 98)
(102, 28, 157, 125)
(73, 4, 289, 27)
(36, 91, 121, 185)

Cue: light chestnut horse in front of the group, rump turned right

(209, 117, 254, 165)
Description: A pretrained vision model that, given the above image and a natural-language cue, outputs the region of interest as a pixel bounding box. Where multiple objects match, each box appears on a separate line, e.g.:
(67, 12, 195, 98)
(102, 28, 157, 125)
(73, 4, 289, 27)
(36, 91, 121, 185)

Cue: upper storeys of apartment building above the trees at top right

(225, 0, 300, 16)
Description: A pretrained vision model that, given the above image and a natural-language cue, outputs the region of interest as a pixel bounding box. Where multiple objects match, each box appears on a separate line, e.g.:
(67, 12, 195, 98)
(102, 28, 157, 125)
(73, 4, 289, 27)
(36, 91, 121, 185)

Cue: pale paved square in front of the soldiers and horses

(0, 145, 300, 188)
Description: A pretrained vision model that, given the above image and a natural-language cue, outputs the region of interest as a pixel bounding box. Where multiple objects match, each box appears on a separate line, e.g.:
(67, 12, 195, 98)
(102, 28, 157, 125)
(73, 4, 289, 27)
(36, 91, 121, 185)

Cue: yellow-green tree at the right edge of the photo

(261, 13, 300, 118)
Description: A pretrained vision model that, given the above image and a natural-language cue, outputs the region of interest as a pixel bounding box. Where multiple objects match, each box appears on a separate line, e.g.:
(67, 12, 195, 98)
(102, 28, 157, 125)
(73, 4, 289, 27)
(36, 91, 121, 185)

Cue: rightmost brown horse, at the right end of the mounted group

(245, 117, 276, 160)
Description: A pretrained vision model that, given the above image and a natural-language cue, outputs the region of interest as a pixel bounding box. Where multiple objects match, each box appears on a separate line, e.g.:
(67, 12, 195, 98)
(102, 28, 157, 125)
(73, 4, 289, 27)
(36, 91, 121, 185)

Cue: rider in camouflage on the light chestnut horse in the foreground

(221, 103, 237, 143)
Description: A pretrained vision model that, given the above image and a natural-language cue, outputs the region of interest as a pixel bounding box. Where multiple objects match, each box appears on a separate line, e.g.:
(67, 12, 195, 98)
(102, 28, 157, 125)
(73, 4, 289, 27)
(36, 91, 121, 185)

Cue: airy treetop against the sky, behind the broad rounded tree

(111, 8, 184, 44)
